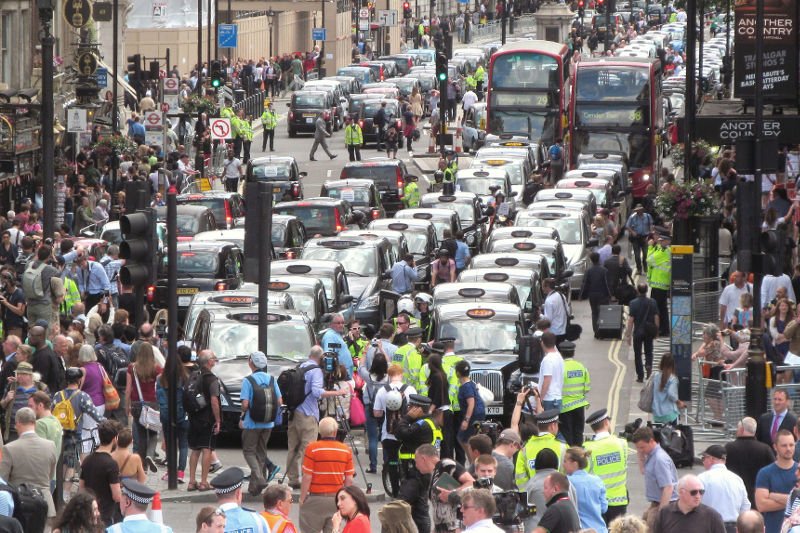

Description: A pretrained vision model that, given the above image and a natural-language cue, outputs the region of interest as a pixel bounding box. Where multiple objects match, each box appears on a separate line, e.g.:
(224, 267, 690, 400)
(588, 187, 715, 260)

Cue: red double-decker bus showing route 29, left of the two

(486, 41, 570, 146)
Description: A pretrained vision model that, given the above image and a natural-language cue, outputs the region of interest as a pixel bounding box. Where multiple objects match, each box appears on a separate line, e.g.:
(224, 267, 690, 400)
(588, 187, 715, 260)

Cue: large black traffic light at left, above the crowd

(119, 209, 158, 287)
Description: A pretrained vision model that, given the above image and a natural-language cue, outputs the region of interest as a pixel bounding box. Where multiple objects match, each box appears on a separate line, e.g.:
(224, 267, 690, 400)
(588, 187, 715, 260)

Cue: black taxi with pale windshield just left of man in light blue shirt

(300, 236, 393, 329)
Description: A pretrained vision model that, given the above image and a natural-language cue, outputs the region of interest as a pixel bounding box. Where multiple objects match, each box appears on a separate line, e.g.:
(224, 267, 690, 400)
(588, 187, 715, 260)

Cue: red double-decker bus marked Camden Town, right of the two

(570, 57, 664, 198)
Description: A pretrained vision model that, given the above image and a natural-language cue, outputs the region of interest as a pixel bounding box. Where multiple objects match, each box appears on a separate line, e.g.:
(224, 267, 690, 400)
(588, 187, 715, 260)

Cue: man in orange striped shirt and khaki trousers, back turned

(300, 417, 355, 533)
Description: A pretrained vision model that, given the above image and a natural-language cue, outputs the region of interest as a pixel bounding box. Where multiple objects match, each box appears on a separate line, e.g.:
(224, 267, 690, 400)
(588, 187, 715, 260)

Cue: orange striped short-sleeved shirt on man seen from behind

(303, 438, 355, 494)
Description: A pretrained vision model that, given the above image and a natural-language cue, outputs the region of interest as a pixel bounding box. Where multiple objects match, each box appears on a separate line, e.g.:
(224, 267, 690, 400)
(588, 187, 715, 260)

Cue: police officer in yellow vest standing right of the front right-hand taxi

(558, 341, 591, 446)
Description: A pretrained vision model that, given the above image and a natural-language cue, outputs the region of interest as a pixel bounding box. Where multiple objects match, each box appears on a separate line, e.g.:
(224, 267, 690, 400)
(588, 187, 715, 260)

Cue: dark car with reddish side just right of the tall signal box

(273, 198, 367, 237)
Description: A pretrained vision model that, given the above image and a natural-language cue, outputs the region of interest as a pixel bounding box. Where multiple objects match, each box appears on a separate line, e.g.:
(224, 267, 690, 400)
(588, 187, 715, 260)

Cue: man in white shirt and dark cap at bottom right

(697, 444, 750, 532)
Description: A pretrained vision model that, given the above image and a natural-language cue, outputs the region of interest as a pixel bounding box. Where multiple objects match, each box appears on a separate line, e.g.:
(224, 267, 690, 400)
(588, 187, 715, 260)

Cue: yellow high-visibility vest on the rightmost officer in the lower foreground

(583, 435, 628, 507)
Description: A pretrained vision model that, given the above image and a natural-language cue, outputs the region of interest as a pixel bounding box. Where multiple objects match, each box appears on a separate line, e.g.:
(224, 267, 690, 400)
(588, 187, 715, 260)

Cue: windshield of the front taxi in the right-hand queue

(437, 317, 517, 353)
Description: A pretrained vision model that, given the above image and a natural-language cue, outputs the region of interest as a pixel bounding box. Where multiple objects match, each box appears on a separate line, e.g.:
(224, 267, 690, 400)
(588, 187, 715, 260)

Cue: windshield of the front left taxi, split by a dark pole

(208, 320, 311, 360)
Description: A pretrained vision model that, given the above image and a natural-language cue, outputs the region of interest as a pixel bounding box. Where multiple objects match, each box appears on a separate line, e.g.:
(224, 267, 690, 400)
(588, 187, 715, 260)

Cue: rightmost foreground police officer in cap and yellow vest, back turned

(583, 409, 628, 524)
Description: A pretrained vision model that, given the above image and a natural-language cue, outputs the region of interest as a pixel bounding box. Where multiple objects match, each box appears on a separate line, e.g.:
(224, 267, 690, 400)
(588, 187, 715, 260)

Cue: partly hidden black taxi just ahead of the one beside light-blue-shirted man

(270, 259, 355, 322)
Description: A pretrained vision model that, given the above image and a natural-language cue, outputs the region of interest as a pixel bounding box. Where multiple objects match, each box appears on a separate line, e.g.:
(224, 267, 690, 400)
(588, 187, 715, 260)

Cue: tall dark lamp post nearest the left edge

(36, 0, 55, 237)
